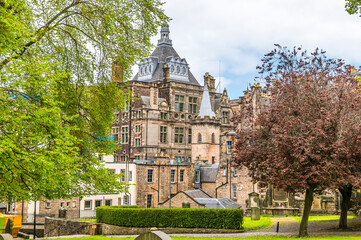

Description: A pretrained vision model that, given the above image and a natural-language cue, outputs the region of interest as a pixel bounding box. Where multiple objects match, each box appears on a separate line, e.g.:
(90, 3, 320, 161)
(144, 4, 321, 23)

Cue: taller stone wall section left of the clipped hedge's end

(44, 218, 100, 237)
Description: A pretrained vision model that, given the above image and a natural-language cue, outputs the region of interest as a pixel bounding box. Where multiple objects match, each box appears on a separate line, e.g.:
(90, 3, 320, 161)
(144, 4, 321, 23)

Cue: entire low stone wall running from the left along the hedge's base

(44, 218, 243, 237)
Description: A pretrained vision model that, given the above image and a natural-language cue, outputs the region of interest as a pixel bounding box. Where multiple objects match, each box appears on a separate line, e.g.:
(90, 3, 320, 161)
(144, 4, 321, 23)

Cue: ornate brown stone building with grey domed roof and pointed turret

(111, 26, 258, 207)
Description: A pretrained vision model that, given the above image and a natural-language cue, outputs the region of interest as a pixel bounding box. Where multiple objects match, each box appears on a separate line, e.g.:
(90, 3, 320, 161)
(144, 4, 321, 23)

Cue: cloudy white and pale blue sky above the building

(134, 0, 361, 99)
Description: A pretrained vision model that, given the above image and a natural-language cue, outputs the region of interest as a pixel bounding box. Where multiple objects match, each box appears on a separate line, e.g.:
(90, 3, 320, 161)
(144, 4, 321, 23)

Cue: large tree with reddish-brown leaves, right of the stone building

(234, 45, 361, 237)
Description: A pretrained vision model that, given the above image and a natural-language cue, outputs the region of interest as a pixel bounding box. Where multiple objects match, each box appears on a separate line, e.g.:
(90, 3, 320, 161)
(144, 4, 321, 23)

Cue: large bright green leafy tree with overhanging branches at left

(0, 0, 169, 201)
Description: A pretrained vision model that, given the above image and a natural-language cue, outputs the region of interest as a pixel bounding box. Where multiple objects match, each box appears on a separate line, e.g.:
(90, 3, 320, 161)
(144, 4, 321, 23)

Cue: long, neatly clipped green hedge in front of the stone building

(96, 206, 243, 229)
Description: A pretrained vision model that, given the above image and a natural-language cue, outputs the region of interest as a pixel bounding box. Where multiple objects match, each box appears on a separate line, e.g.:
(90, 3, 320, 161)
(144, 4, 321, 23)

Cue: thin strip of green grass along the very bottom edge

(44, 236, 360, 240)
